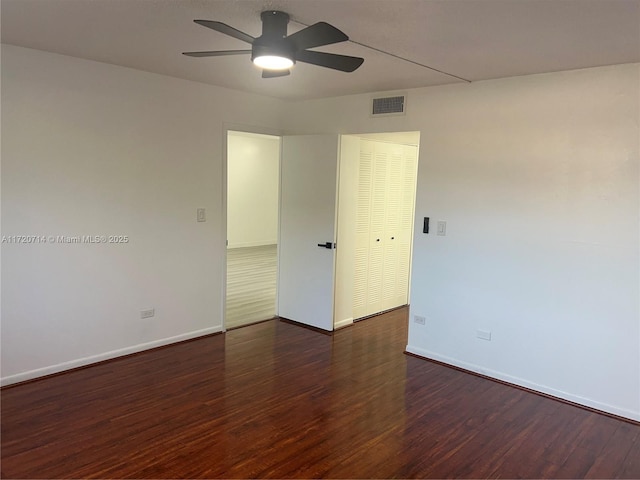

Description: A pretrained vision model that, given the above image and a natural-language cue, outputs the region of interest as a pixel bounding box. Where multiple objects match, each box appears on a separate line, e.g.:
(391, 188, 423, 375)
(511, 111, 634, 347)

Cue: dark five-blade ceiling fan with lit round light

(183, 10, 364, 78)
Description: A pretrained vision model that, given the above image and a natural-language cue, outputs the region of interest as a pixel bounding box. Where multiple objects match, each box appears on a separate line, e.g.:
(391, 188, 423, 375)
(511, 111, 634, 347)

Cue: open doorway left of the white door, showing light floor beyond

(225, 130, 280, 329)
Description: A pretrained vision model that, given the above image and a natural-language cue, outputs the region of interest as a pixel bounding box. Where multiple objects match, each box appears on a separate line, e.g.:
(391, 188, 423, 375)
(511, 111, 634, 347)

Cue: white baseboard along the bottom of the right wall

(406, 345, 640, 421)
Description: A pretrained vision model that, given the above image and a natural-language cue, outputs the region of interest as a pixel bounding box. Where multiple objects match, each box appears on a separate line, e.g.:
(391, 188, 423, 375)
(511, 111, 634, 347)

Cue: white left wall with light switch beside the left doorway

(1, 45, 282, 383)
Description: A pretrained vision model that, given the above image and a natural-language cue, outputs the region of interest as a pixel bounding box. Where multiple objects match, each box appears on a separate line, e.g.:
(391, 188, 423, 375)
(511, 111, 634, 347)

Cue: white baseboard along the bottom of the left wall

(0, 326, 223, 387)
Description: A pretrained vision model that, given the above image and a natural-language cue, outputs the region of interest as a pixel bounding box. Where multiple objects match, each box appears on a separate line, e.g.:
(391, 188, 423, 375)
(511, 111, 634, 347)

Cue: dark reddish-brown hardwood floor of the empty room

(1, 309, 640, 478)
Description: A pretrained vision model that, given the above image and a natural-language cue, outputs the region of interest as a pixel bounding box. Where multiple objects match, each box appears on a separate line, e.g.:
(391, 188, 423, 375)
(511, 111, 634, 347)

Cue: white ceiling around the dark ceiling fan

(0, 0, 640, 99)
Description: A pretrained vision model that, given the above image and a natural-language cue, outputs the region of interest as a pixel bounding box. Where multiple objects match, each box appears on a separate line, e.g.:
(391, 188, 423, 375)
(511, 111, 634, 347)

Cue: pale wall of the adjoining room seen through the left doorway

(227, 132, 280, 248)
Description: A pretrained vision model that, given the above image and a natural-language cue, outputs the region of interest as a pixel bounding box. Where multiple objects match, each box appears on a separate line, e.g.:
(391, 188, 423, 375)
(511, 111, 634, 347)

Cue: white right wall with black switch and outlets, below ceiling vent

(285, 65, 640, 419)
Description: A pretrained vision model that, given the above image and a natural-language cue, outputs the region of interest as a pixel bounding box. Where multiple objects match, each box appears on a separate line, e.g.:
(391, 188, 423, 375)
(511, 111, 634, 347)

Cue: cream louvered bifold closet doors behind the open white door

(353, 140, 418, 318)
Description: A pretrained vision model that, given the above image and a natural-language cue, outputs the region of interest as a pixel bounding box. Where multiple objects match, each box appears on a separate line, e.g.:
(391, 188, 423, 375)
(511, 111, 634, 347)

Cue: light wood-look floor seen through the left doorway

(225, 245, 277, 329)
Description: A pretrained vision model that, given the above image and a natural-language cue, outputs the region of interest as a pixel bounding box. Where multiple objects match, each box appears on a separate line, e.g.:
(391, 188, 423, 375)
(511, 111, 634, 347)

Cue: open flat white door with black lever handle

(278, 135, 340, 331)
